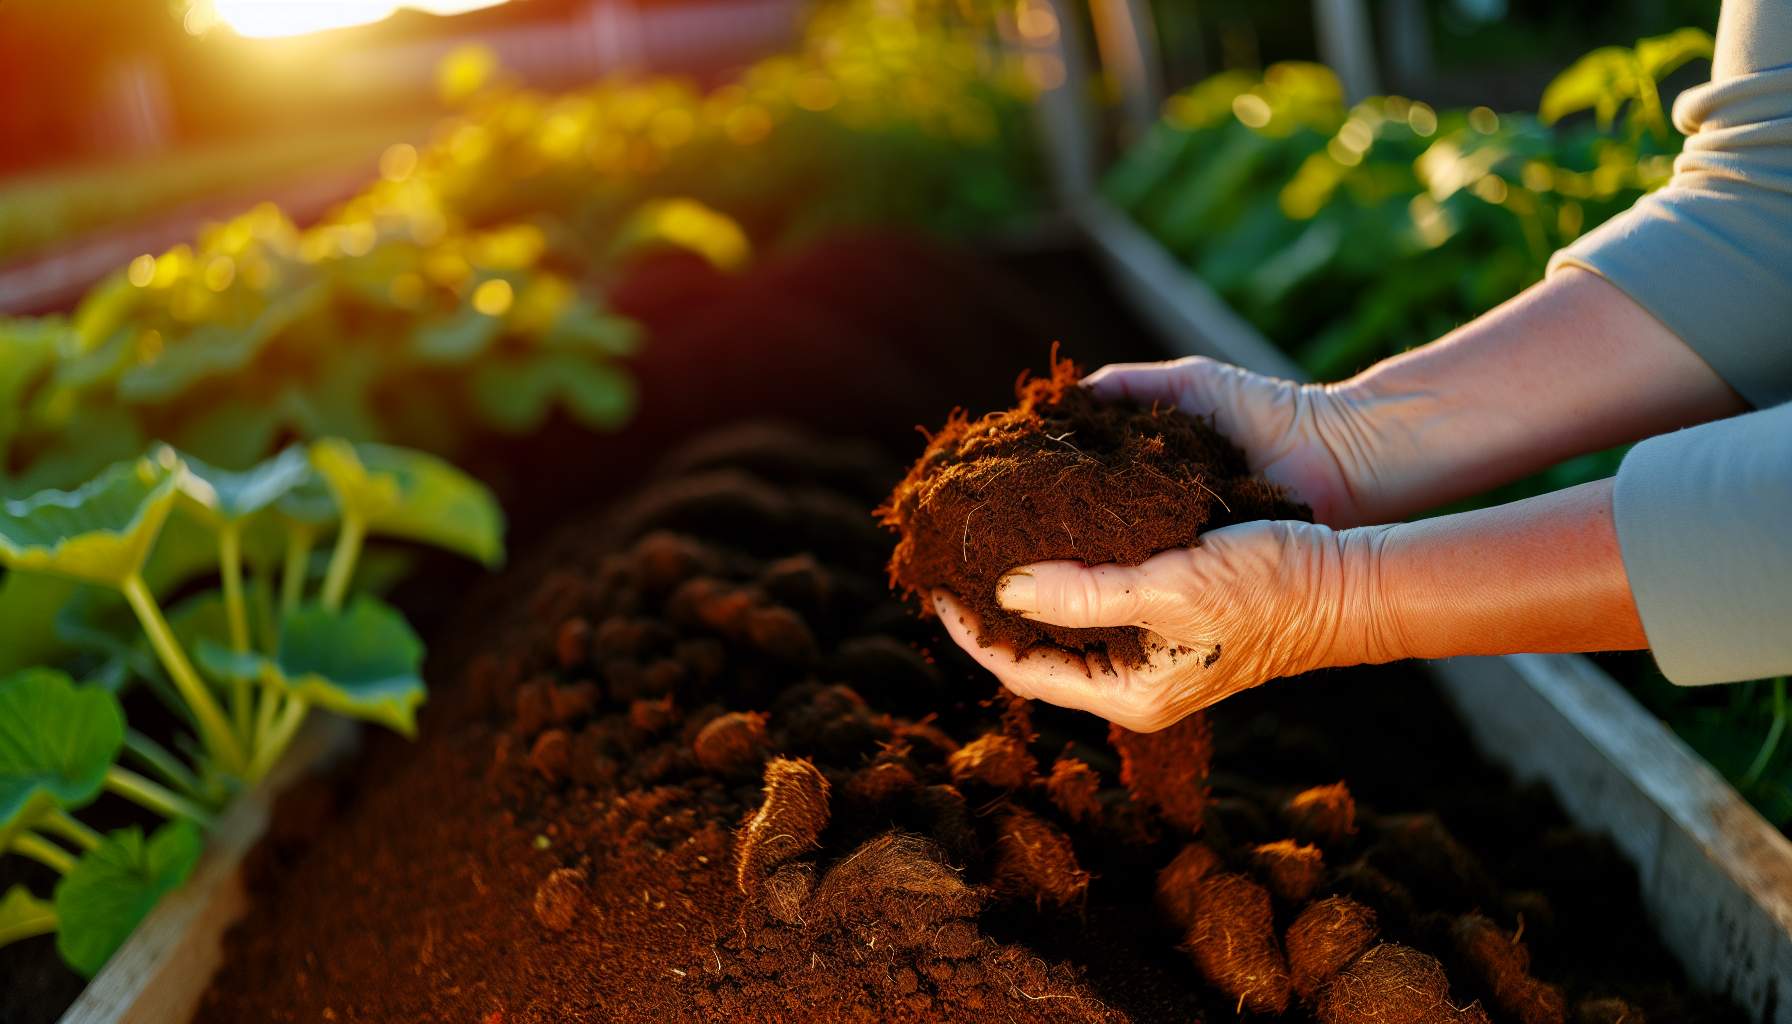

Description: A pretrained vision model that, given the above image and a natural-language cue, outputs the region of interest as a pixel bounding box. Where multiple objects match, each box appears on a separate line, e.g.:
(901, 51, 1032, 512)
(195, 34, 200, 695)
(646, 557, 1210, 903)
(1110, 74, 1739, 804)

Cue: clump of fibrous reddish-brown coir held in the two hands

(878, 353, 1312, 665)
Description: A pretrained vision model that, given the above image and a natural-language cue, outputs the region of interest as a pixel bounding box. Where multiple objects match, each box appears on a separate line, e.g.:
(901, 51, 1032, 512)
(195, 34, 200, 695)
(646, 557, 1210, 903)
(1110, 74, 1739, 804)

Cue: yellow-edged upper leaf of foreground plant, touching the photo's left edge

(0, 459, 179, 586)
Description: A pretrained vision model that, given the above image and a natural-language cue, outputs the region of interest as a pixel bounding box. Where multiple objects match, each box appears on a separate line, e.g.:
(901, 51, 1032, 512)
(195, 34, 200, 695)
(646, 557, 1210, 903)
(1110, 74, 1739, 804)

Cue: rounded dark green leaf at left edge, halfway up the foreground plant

(0, 669, 124, 848)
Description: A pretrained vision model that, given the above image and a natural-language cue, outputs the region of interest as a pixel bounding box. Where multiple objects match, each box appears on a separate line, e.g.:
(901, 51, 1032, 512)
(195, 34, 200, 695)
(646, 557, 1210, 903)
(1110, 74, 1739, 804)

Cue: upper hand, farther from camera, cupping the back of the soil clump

(1082, 355, 1405, 525)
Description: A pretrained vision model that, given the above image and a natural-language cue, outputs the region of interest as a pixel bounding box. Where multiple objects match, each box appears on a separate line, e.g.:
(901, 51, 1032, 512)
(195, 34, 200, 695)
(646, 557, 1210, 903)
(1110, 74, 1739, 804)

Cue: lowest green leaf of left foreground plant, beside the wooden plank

(56, 821, 204, 977)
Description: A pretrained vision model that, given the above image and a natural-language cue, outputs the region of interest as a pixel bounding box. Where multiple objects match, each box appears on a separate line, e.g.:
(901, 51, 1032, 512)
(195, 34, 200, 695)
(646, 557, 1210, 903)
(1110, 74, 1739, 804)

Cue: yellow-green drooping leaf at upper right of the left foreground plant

(312, 438, 504, 565)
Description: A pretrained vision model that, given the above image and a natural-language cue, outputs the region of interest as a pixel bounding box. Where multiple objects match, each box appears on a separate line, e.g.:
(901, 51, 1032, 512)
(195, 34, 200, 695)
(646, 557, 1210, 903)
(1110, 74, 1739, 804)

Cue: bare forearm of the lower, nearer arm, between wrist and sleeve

(1333, 481, 1647, 664)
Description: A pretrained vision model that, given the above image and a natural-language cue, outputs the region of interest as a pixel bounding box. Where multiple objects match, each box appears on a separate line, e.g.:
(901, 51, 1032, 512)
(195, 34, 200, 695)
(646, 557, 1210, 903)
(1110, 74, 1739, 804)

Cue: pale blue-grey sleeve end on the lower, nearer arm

(1613, 405, 1792, 685)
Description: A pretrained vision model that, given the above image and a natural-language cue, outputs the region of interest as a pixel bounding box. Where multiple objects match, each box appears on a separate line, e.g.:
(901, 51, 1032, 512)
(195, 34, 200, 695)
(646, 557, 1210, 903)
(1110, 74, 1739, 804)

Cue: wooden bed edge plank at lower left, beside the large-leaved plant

(61, 716, 355, 1024)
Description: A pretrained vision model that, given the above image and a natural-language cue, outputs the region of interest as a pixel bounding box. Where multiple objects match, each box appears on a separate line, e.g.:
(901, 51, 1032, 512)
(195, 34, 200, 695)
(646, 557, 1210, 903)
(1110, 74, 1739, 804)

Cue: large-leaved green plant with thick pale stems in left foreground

(0, 439, 504, 976)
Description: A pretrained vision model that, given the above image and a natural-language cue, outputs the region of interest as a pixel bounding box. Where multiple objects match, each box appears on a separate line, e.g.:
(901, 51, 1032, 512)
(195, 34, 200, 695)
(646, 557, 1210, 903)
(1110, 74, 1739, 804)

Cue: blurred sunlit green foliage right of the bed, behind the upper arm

(1104, 29, 1711, 378)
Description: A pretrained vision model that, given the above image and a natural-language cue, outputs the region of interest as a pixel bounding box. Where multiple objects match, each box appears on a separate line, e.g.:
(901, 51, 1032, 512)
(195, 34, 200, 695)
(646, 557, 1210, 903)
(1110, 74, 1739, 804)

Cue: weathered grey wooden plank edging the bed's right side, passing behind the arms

(1075, 191, 1792, 1024)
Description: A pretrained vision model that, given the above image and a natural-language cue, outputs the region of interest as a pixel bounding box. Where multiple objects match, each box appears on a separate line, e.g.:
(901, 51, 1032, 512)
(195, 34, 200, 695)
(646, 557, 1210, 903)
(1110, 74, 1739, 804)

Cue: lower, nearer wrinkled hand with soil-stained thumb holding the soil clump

(934, 522, 1401, 732)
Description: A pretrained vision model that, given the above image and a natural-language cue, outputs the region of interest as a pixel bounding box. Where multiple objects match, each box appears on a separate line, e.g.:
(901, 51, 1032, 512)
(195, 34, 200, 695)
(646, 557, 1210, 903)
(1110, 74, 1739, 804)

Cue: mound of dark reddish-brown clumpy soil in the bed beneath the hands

(199, 421, 1731, 1024)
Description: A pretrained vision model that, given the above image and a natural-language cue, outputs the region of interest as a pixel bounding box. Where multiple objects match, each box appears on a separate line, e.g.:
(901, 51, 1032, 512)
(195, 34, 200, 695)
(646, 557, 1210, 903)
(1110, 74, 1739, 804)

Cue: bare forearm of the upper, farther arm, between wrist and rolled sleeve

(1328, 269, 1747, 522)
